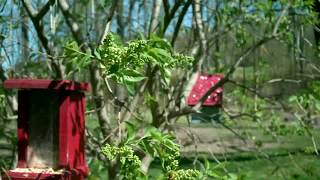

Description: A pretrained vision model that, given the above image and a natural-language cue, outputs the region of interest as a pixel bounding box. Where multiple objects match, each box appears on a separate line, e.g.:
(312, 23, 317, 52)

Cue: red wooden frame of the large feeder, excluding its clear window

(2, 80, 90, 180)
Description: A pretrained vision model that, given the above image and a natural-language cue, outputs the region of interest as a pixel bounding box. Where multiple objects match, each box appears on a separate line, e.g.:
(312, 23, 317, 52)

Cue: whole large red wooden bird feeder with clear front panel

(2, 79, 90, 180)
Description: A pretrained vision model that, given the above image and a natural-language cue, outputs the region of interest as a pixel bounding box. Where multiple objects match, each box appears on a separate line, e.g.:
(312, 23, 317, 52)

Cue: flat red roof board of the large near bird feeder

(4, 79, 91, 91)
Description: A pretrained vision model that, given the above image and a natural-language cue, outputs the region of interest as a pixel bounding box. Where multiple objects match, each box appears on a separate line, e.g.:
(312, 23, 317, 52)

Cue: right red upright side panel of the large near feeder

(59, 92, 88, 175)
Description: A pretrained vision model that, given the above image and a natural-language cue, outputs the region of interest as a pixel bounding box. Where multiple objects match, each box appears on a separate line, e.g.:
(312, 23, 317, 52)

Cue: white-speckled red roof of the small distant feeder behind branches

(187, 74, 224, 106)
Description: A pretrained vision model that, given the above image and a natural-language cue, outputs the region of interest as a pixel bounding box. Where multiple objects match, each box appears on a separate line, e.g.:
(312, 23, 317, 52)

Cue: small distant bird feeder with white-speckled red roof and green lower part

(187, 74, 224, 123)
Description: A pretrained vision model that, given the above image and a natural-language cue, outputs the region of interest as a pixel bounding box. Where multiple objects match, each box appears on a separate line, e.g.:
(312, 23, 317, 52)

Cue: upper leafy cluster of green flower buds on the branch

(95, 34, 193, 82)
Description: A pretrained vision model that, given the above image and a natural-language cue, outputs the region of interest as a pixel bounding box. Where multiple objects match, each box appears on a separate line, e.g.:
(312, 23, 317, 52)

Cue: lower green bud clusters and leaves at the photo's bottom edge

(102, 129, 200, 180)
